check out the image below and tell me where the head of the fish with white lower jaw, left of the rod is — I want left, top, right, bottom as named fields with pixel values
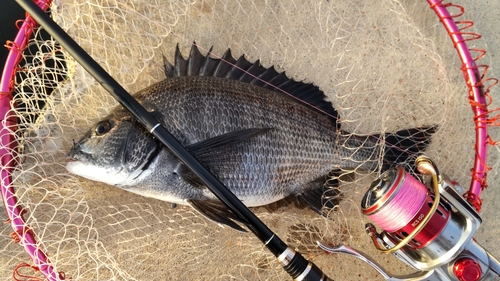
left=66, top=112, right=160, bottom=187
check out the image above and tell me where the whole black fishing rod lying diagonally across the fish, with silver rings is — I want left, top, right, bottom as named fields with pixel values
left=16, top=0, right=331, bottom=281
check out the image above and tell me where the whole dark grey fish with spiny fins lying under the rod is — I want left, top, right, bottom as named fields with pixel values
left=66, top=44, right=436, bottom=231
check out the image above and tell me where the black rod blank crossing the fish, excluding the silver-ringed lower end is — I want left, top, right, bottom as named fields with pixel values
left=16, top=0, right=278, bottom=247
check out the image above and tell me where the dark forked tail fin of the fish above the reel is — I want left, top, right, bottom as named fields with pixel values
left=379, top=126, right=437, bottom=172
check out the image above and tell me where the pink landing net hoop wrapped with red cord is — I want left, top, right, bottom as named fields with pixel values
left=0, top=0, right=498, bottom=280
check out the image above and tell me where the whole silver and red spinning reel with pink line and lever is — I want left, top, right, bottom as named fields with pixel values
left=318, top=156, right=500, bottom=281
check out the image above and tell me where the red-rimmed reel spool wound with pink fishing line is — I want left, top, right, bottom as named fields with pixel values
left=361, top=164, right=450, bottom=250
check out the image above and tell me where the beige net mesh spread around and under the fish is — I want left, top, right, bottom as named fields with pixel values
left=0, top=0, right=500, bottom=280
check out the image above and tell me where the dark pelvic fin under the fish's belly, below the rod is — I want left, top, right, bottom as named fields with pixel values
left=186, top=200, right=247, bottom=232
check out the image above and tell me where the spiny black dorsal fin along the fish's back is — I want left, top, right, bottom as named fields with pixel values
left=163, top=42, right=340, bottom=129
